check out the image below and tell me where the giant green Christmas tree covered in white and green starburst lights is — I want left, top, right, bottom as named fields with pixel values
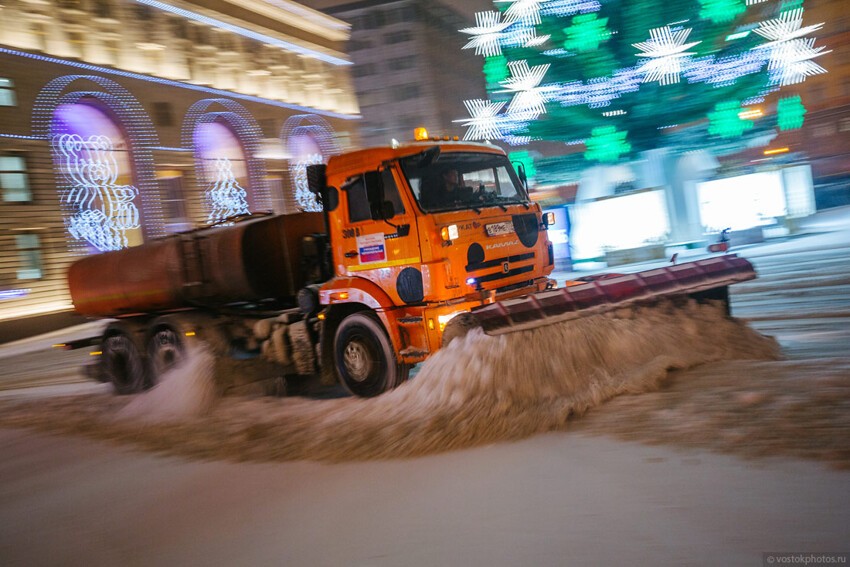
left=461, top=0, right=825, bottom=162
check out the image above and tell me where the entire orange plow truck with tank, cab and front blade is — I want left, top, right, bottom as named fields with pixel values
left=68, top=140, right=755, bottom=396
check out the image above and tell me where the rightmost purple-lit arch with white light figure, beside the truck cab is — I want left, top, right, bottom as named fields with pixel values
left=280, top=114, right=339, bottom=212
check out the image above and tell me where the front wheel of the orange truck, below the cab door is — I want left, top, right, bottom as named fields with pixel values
left=334, top=313, right=410, bottom=398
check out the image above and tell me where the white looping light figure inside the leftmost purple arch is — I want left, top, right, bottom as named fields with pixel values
left=52, top=134, right=139, bottom=252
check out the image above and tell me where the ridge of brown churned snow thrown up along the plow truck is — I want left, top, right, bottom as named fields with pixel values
left=0, top=302, right=779, bottom=461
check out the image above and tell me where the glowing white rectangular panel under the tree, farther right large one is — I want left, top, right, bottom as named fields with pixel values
left=697, top=171, right=787, bottom=232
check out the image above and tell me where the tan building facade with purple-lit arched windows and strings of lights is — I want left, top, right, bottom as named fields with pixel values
left=0, top=0, right=359, bottom=319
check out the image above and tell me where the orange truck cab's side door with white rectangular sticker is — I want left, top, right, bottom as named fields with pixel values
left=342, top=168, right=421, bottom=303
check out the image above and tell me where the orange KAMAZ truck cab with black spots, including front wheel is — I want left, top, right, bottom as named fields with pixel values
left=311, top=141, right=554, bottom=395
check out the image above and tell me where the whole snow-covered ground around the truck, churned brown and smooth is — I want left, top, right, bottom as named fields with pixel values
left=0, top=211, right=850, bottom=566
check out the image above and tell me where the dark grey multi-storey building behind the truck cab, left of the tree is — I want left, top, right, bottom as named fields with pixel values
left=324, top=0, right=487, bottom=145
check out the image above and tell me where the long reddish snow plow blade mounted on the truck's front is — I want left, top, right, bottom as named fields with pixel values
left=472, top=254, right=756, bottom=335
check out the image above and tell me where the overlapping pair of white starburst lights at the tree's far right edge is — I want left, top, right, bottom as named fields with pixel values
left=753, top=8, right=829, bottom=86
